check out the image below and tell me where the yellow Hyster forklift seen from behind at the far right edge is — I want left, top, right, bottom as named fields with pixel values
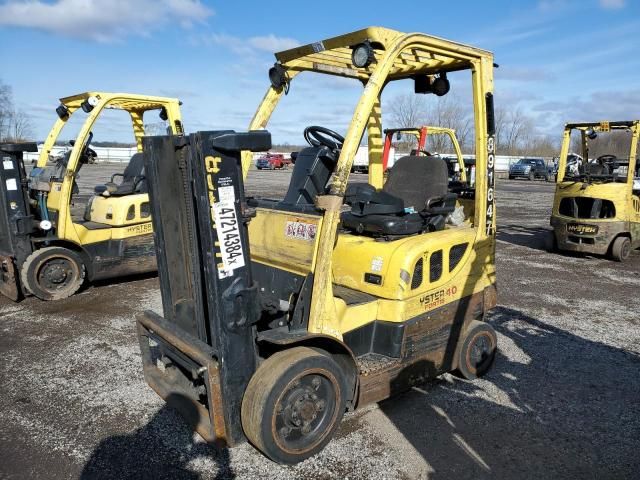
left=549, top=120, right=640, bottom=262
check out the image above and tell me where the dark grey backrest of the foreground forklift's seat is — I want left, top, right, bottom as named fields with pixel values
left=382, top=155, right=449, bottom=212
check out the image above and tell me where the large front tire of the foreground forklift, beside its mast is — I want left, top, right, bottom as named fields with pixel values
left=241, top=347, right=347, bottom=464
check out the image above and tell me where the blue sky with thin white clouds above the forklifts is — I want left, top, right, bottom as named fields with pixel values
left=0, top=0, right=640, bottom=144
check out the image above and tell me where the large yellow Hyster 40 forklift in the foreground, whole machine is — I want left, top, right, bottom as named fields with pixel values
left=137, top=27, right=497, bottom=463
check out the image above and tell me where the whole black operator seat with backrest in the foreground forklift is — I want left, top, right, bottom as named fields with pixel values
left=341, top=155, right=457, bottom=236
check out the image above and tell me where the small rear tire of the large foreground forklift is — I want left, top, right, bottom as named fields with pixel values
left=455, top=320, right=498, bottom=380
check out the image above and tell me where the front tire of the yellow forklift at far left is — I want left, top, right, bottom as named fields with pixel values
left=20, top=247, right=85, bottom=300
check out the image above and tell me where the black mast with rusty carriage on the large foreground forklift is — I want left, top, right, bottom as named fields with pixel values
left=138, top=131, right=271, bottom=445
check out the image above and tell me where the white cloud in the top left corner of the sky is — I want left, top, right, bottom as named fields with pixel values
left=0, top=0, right=214, bottom=42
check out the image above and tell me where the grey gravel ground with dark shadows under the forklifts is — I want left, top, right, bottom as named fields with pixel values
left=0, top=166, right=640, bottom=479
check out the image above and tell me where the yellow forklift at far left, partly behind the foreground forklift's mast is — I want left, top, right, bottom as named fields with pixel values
left=0, top=92, right=183, bottom=300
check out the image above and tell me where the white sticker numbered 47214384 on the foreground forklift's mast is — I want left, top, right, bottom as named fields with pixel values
left=211, top=186, right=245, bottom=278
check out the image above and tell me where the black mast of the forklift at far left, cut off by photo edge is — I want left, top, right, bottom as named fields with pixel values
left=0, top=143, right=38, bottom=300
